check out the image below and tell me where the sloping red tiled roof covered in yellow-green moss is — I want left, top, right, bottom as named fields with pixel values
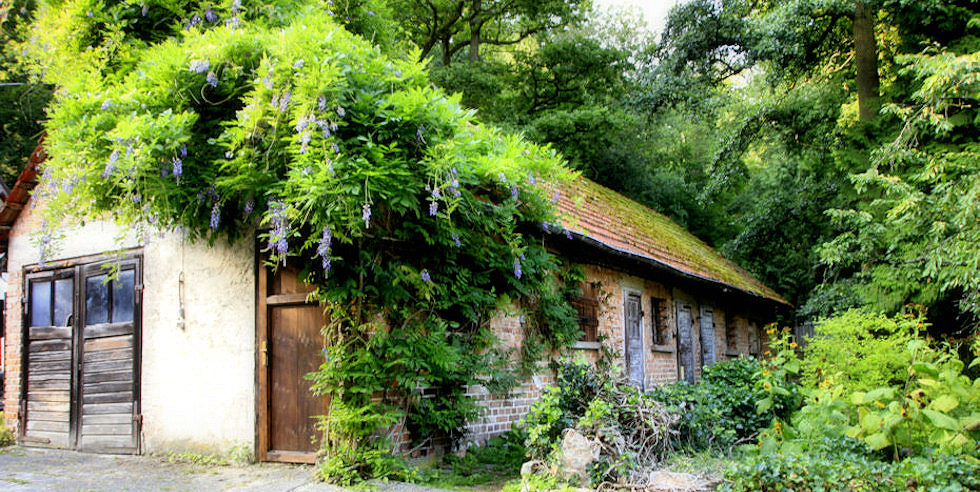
left=558, top=177, right=788, bottom=304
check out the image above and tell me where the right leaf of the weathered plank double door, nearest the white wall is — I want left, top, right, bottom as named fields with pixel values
left=76, top=262, right=140, bottom=454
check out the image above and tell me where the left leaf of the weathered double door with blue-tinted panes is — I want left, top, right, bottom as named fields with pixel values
left=21, top=270, right=75, bottom=448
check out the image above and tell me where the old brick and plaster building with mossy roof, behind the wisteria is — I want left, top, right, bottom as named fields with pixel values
left=0, top=148, right=786, bottom=462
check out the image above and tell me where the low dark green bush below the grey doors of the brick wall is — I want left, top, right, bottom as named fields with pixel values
left=649, top=358, right=793, bottom=449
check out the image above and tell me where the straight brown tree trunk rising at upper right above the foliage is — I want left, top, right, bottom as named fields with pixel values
left=854, top=0, right=879, bottom=121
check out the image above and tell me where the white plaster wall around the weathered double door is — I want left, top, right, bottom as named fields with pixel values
left=8, top=209, right=255, bottom=453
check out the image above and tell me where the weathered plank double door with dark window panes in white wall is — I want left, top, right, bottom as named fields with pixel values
left=20, top=257, right=142, bottom=454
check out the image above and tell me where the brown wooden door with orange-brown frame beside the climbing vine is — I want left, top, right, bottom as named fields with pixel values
left=258, top=267, right=328, bottom=463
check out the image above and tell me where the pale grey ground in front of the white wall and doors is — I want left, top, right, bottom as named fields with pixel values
left=0, top=446, right=452, bottom=492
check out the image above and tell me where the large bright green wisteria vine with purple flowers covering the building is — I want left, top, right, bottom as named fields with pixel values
left=24, top=0, right=578, bottom=481
